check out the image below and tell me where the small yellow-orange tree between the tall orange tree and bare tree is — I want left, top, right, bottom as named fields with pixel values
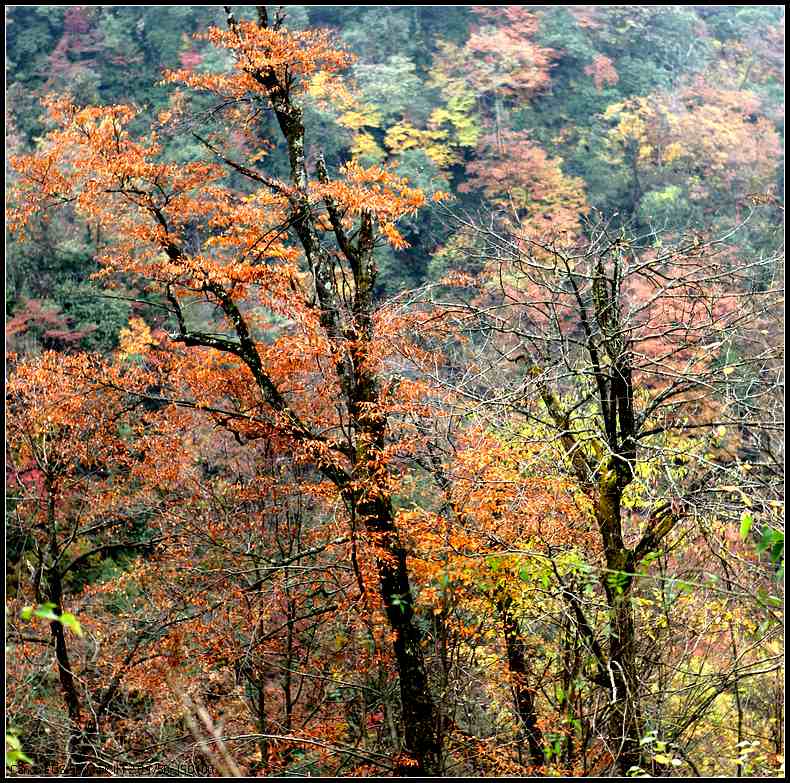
left=414, top=426, right=581, bottom=773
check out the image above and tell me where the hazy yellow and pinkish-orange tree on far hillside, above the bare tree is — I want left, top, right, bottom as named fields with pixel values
left=604, top=77, right=780, bottom=226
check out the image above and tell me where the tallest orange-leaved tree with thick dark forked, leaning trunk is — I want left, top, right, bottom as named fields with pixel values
left=13, top=7, right=440, bottom=774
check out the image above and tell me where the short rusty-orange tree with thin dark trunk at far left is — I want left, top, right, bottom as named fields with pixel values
left=6, top=351, right=170, bottom=775
